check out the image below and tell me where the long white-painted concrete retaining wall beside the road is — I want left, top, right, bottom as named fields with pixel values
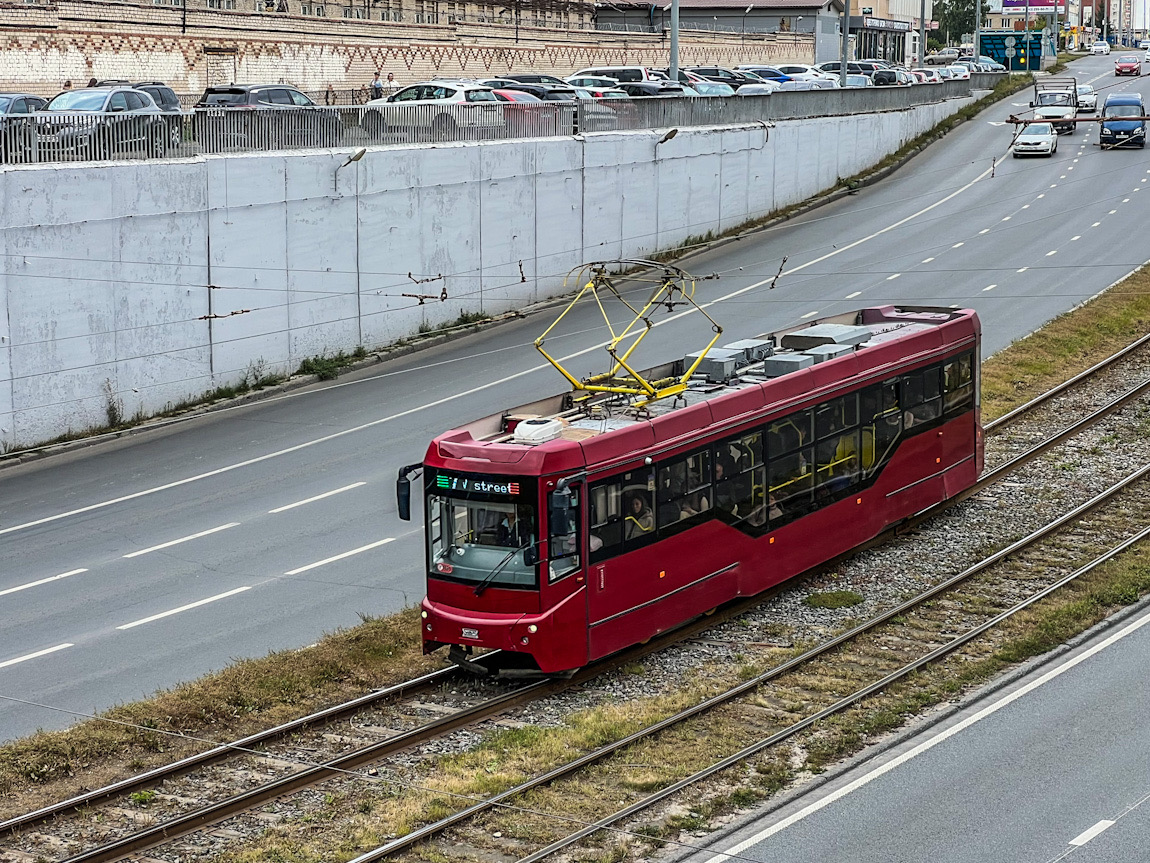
left=0, top=98, right=969, bottom=450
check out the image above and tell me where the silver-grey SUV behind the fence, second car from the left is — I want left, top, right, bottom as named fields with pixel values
left=36, top=86, right=170, bottom=159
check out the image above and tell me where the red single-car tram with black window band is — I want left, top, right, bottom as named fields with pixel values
left=399, top=306, right=983, bottom=673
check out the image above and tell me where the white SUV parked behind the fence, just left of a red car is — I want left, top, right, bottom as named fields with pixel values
left=360, top=81, right=506, bottom=140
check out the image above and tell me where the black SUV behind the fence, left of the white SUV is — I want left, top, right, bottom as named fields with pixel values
left=194, top=84, right=343, bottom=152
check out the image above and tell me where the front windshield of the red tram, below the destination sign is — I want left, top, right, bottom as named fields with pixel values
left=427, top=494, right=538, bottom=588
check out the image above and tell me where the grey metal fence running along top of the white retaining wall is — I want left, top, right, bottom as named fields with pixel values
left=0, top=75, right=1002, bottom=165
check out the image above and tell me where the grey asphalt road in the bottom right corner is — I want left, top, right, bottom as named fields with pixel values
left=675, top=608, right=1150, bottom=863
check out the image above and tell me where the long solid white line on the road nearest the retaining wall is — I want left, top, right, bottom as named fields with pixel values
left=0, top=154, right=1010, bottom=536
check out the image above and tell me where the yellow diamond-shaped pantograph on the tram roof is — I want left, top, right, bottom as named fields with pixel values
left=535, top=259, right=722, bottom=407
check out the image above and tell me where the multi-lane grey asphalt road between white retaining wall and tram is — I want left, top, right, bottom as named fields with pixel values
left=0, top=56, right=1150, bottom=739
